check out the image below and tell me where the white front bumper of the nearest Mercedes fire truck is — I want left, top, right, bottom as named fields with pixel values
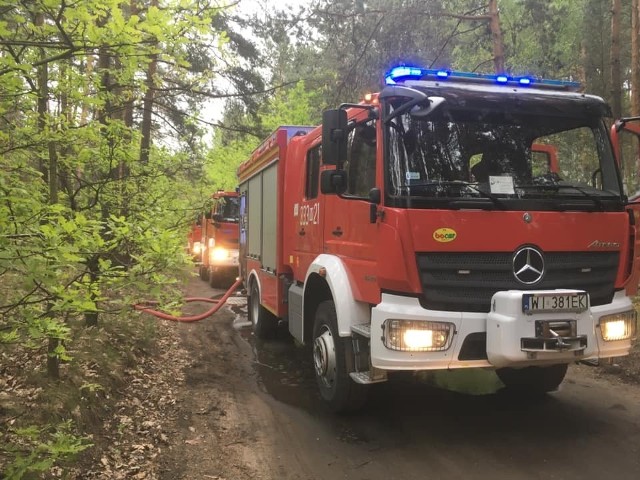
left=370, top=290, right=634, bottom=370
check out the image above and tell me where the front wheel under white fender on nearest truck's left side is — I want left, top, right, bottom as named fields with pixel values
left=313, top=300, right=368, bottom=412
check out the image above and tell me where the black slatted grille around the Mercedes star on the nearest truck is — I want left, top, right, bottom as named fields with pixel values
left=416, top=252, right=619, bottom=312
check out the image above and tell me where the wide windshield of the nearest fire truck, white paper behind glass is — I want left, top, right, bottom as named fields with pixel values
left=385, top=106, right=620, bottom=210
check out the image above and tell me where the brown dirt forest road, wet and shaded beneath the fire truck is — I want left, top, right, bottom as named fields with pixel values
left=159, top=279, right=640, bottom=480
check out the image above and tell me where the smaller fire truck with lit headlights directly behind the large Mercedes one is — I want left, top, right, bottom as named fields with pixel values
left=198, top=191, right=239, bottom=288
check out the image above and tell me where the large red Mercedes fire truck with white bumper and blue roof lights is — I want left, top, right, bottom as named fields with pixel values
left=238, top=66, right=640, bottom=411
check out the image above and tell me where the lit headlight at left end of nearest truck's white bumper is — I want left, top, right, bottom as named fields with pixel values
left=383, top=319, right=455, bottom=352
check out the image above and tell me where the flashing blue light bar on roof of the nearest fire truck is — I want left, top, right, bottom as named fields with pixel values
left=384, top=65, right=580, bottom=90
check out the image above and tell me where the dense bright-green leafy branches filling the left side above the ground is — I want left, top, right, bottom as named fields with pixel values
left=0, top=0, right=226, bottom=346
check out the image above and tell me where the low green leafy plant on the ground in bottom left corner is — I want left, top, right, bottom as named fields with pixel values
left=0, top=421, right=92, bottom=480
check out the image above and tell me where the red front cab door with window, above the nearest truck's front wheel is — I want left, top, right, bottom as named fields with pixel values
left=324, top=120, right=381, bottom=301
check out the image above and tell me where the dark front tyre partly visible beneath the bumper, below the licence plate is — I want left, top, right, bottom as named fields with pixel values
left=496, top=363, right=569, bottom=395
